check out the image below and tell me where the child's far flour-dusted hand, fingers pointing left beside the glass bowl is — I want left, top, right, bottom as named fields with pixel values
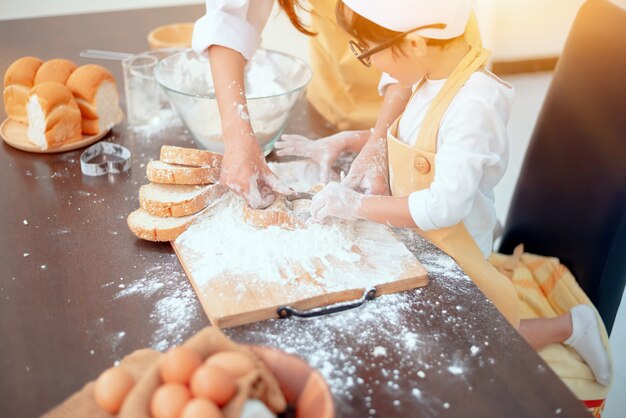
left=275, top=131, right=357, bottom=183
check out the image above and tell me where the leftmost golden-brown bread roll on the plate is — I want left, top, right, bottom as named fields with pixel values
left=3, top=57, right=43, bottom=125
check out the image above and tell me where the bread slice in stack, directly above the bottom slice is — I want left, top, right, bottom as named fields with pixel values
left=139, top=183, right=227, bottom=217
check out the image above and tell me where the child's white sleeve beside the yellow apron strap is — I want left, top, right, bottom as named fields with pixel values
left=409, top=99, right=508, bottom=231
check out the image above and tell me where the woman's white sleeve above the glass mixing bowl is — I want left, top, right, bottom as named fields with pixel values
left=191, top=0, right=274, bottom=59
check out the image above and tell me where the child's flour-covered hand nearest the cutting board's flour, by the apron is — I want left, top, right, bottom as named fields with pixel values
left=311, top=182, right=364, bottom=222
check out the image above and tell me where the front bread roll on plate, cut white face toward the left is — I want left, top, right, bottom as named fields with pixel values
left=26, top=83, right=82, bottom=150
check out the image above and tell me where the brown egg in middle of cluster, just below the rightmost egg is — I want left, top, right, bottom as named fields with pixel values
left=191, top=366, right=237, bottom=407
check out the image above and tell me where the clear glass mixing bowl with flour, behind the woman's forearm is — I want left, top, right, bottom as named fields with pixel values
left=154, top=49, right=312, bottom=155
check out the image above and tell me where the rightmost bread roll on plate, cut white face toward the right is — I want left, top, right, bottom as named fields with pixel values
left=67, top=64, right=124, bottom=135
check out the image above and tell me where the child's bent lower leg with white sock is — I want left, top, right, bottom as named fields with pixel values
left=519, top=305, right=611, bottom=385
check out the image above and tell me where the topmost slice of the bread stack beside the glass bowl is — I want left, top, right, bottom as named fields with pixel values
left=146, top=161, right=220, bottom=184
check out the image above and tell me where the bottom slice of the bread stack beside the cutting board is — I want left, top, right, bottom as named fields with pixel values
left=126, top=209, right=202, bottom=242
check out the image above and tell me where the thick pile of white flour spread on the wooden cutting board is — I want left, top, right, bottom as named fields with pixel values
left=176, top=193, right=360, bottom=283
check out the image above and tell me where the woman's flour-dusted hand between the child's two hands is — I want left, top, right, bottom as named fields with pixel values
left=341, top=138, right=391, bottom=196
